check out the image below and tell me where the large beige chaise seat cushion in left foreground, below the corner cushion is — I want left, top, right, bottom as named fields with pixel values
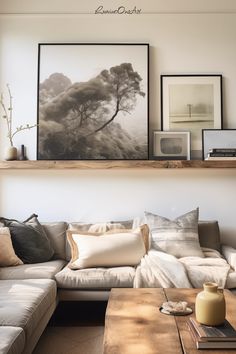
left=0, top=279, right=57, bottom=340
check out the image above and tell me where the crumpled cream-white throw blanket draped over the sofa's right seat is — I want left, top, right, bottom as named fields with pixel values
left=134, top=248, right=231, bottom=288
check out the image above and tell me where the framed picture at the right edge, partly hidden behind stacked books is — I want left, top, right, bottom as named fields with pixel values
left=202, top=129, right=236, bottom=160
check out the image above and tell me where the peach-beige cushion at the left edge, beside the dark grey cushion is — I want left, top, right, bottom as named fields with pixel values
left=0, top=227, right=23, bottom=267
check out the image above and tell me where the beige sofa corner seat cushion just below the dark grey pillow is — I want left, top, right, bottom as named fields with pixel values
left=0, top=260, right=66, bottom=280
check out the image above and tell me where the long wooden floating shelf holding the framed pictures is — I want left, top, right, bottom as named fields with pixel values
left=0, top=160, right=236, bottom=170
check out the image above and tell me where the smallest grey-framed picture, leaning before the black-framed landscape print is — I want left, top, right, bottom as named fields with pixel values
left=153, top=131, right=190, bottom=160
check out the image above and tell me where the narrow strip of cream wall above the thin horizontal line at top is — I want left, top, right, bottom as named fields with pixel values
left=0, top=0, right=236, bottom=14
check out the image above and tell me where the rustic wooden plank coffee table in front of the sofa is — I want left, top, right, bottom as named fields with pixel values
left=103, top=288, right=236, bottom=354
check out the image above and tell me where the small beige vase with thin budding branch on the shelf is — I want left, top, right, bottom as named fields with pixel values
left=0, top=84, right=37, bottom=160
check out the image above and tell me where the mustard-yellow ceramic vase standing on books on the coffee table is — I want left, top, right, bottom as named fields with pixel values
left=195, top=282, right=226, bottom=326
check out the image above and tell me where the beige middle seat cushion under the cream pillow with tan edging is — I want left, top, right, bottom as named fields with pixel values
left=55, top=267, right=135, bottom=289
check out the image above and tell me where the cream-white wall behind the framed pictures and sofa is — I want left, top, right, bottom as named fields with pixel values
left=0, top=0, right=236, bottom=246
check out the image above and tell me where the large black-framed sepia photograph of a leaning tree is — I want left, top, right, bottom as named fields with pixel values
left=37, top=43, right=149, bottom=160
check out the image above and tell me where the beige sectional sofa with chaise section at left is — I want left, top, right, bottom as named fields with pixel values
left=0, top=216, right=236, bottom=354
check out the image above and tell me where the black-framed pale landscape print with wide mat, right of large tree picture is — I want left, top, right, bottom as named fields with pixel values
left=161, top=75, right=222, bottom=159
